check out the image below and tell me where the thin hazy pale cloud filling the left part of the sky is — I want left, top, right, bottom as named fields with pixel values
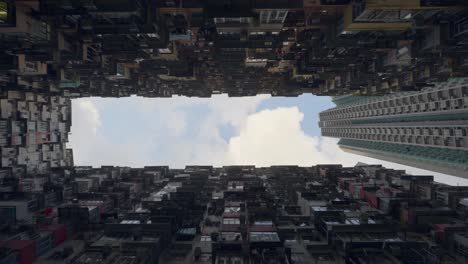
left=69, top=95, right=267, bottom=168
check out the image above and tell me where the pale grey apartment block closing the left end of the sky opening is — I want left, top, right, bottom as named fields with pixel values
left=0, top=91, right=73, bottom=175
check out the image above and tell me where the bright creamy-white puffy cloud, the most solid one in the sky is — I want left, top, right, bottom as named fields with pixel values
left=228, top=107, right=316, bottom=166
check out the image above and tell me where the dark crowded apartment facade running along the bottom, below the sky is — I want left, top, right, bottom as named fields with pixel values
left=0, top=163, right=468, bottom=264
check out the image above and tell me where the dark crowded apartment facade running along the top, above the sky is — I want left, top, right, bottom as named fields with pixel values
left=0, top=0, right=468, bottom=98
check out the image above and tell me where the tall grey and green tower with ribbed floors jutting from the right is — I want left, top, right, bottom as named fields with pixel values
left=319, top=78, right=468, bottom=177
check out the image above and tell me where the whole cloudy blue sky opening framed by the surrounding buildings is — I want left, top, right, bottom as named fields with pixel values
left=68, top=95, right=468, bottom=185
